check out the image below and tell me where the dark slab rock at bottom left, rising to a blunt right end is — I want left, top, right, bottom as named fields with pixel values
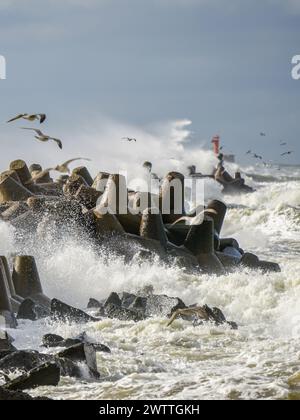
left=4, top=363, right=60, bottom=391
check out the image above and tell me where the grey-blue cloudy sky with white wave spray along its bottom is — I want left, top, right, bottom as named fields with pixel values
left=0, top=0, right=300, bottom=175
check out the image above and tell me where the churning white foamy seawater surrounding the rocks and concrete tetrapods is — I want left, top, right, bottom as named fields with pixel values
left=0, top=164, right=300, bottom=399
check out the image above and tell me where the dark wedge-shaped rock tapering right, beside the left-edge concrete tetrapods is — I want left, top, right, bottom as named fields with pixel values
left=51, top=299, right=99, bottom=323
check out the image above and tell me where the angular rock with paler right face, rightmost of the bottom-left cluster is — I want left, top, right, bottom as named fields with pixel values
left=57, top=343, right=100, bottom=379
